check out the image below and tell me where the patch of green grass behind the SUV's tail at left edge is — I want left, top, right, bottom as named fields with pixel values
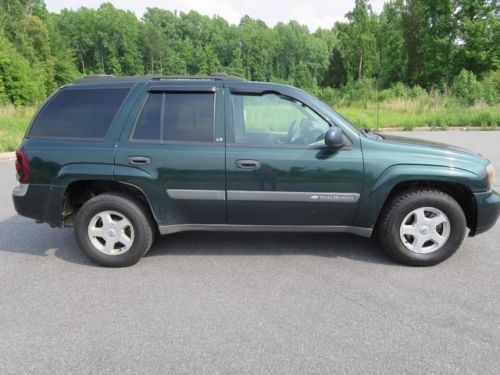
left=0, top=106, right=35, bottom=152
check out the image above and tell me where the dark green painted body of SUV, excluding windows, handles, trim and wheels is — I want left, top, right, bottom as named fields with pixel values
left=14, top=80, right=500, bottom=239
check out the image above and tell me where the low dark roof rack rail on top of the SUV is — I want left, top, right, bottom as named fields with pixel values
left=74, top=73, right=246, bottom=83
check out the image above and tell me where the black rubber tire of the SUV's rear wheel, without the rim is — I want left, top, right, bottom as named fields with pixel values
left=74, top=193, right=155, bottom=267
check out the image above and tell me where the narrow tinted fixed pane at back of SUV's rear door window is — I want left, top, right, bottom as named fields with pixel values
left=132, top=94, right=162, bottom=141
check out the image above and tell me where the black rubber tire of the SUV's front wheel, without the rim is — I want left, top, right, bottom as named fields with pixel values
left=376, top=188, right=466, bottom=266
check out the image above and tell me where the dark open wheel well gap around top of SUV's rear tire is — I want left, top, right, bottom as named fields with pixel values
left=61, top=180, right=158, bottom=226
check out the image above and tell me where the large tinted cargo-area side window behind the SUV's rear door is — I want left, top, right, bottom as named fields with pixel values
left=30, top=89, right=129, bottom=139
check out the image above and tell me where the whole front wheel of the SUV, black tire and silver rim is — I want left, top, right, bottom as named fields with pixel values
left=377, top=189, right=466, bottom=266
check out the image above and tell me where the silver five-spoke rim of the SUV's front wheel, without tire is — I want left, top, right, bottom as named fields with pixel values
left=399, top=207, right=450, bottom=254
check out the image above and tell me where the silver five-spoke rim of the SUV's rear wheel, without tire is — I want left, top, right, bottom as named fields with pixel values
left=88, top=211, right=135, bottom=255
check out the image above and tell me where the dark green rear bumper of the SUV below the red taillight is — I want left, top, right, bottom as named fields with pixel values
left=12, top=184, right=64, bottom=226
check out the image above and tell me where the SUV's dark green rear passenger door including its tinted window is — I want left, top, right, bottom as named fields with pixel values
left=114, top=81, right=226, bottom=229
